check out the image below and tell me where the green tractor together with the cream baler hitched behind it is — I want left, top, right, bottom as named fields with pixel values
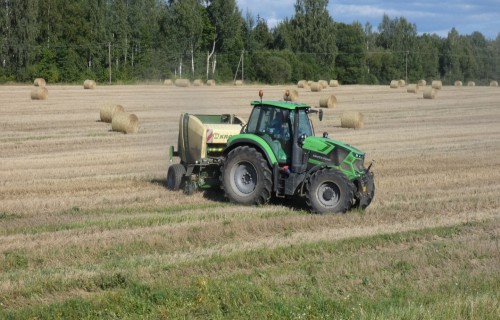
left=167, top=93, right=375, bottom=213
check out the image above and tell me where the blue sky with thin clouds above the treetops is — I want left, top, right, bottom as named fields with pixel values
left=236, top=0, right=500, bottom=40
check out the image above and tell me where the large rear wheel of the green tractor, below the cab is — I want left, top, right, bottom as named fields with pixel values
left=222, top=146, right=273, bottom=205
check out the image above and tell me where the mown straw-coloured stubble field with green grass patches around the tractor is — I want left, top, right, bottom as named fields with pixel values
left=0, top=85, right=500, bottom=319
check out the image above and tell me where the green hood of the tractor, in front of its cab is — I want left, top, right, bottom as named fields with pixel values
left=302, top=137, right=365, bottom=171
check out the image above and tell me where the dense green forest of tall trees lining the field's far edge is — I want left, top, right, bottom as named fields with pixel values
left=0, top=0, right=500, bottom=85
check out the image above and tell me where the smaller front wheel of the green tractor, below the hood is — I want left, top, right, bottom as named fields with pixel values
left=306, top=169, right=354, bottom=213
